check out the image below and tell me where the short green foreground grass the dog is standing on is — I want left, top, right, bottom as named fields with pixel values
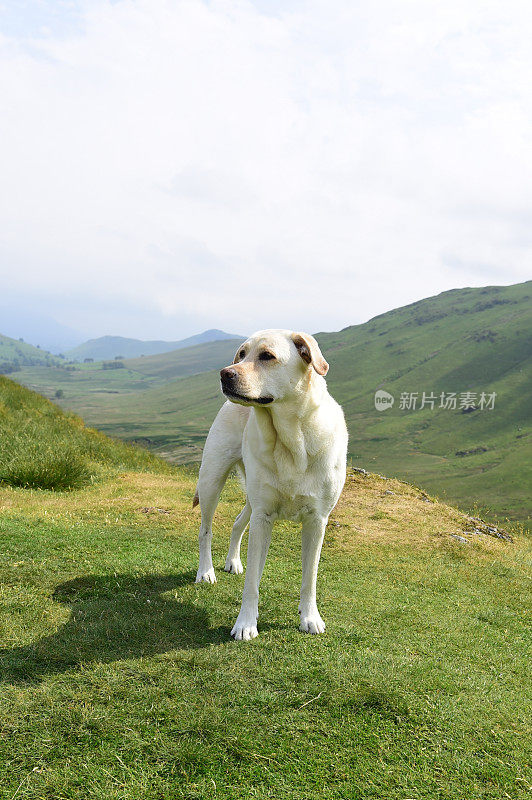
left=0, top=470, right=532, bottom=800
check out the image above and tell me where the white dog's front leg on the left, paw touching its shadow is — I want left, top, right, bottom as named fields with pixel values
left=231, top=513, right=273, bottom=640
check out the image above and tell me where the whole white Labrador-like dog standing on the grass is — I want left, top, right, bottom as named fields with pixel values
left=193, top=330, right=347, bottom=640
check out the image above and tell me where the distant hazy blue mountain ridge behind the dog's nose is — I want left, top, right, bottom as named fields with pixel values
left=65, top=328, right=246, bottom=361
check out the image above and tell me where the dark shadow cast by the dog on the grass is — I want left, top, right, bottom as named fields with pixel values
left=0, top=572, right=229, bottom=682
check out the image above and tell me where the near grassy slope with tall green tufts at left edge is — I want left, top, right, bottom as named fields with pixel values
left=0, top=376, right=167, bottom=490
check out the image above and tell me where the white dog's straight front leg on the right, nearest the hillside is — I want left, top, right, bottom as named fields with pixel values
left=299, top=516, right=327, bottom=633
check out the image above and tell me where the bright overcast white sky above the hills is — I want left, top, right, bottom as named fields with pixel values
left=0, top=0, right=532, bottom=338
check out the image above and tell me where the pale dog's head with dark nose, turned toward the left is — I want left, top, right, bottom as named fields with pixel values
left=220, top=330, right=329, bottom=406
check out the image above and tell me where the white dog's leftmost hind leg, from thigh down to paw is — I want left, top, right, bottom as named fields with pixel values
left=193, top=403, right=249, bottom=583
